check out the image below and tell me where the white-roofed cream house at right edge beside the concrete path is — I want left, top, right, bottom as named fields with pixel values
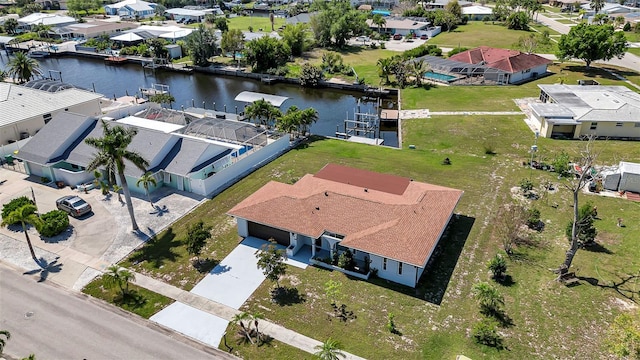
left=530, top=84, right=640, bottom=139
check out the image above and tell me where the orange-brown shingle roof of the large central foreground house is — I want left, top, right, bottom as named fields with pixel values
left=228, top=165, right=463, bottom=267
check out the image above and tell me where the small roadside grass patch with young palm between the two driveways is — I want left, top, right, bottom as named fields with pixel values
left=82, top=277, right=173, bottom=319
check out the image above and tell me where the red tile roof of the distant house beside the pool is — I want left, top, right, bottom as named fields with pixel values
left=449, top=46, right=552, bottom=73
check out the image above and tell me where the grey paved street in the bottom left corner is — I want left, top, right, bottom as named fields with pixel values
left=0, top=266, right=236, bottom=360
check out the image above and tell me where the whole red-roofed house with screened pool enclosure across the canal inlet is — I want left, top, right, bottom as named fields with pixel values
left=449, top=46, right=552, bottom=84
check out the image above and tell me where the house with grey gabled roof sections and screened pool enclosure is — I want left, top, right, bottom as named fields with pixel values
left=15, top=105, right=289, bottom=196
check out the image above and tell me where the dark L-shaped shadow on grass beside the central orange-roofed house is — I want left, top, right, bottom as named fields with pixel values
left=360, top=215, right=476, bottom=305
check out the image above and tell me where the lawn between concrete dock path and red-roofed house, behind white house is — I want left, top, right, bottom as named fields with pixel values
left=402, top=63, right=640, bottom=111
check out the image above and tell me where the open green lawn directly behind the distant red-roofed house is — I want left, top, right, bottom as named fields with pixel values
left=428, top=21, right=544, bottom=49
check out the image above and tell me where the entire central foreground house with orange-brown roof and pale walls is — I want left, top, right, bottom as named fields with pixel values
left=228, top=164, right=463, bottom=287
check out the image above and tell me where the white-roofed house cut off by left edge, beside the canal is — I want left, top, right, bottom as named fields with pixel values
left=0, top=79, right=103, bottom=146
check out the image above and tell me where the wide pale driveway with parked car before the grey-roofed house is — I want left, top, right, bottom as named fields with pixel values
left=0, top=168, right=203, bottom=290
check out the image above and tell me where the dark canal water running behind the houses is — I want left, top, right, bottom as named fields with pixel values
left=0, top=54, right=398, bottom=147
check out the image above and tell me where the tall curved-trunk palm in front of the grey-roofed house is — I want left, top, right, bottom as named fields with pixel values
left=85, top=120, right=149, bottom=231
